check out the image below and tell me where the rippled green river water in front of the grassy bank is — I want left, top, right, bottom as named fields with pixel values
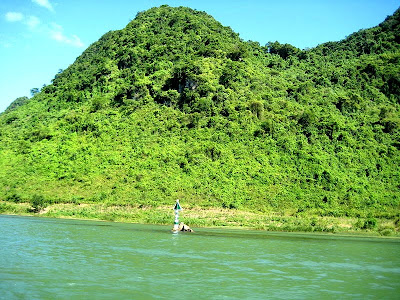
left=0, top=215, right=400, bottom=299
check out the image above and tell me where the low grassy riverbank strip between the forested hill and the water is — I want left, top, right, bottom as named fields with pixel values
left=0, top=201, right=400, bottom=237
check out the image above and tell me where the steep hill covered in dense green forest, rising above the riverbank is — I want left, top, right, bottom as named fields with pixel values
left=0, top=6, right=400, bottom=218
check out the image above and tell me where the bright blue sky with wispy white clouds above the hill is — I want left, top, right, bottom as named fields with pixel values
left=0, top=0, right=399, bottom=112
